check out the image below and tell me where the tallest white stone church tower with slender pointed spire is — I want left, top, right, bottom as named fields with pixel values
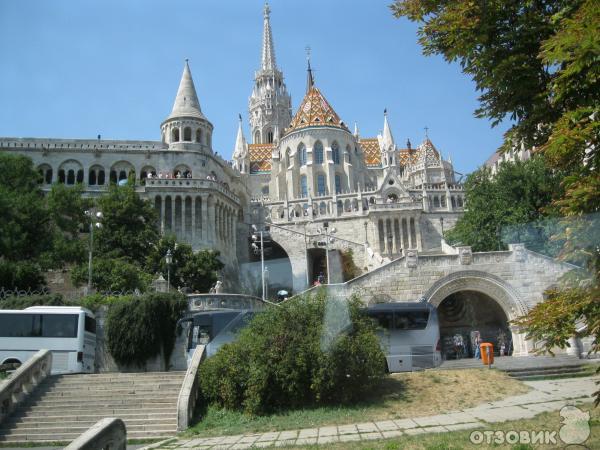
left=248, top=3, right=292, bottom=144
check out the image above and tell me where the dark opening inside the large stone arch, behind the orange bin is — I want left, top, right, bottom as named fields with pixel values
left=437, top=290, right=513, bottom=359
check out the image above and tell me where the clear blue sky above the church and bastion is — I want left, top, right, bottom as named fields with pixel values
left=0, top=0, right=507, bottom=173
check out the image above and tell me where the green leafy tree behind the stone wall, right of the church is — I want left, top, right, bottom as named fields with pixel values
left=445, top=156, right=561, bottom=256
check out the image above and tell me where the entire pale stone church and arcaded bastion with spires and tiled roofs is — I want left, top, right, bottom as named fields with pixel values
left=0, top=5, right=464, bottom=291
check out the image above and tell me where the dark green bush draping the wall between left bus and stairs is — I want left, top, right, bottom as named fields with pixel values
left=106, top=293, right=187, bottom=366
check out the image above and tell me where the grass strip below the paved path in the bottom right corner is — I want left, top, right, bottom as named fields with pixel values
left=286, top=403, right=600, bottom=450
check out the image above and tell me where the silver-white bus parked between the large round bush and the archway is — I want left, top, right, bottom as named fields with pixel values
left=365, top=302, right=442, bottom=372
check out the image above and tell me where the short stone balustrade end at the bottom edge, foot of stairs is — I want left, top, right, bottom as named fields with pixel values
left=65, top=417, right=127, bottom=450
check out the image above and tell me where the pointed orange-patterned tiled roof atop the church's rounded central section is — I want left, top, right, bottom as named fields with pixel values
left=285, top=86, right=348, bottom=133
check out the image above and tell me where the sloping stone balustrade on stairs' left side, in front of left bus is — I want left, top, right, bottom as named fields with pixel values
left=0, top=350, right=52, bottom=423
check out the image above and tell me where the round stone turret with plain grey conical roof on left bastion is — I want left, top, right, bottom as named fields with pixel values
left=160, top=59, right=213, bottom=150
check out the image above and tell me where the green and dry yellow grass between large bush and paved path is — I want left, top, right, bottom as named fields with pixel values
left=183, top=369, right=529, bottom=436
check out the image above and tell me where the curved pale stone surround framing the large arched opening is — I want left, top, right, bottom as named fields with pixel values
left=424, top=270, right=528, bottom=356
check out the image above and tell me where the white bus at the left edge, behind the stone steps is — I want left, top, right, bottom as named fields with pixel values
left=0, top=306, right=96, bottom=374
